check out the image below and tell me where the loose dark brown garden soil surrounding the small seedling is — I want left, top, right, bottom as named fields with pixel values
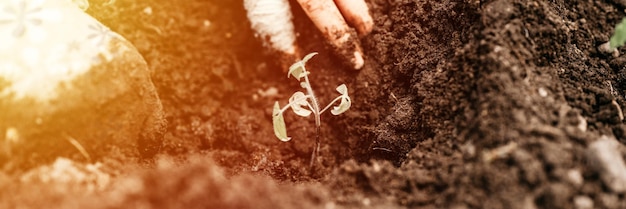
left=0, top=0, right=626, bottom=209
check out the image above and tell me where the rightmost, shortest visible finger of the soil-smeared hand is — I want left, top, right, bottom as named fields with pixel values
left=335, top=0, right=374, bottom=36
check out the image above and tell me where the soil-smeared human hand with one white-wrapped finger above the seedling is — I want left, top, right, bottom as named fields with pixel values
left=244, top=0, right=374, bottom=69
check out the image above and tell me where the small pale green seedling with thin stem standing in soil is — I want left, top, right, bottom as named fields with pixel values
left=272, top=52, right=351, bottom=169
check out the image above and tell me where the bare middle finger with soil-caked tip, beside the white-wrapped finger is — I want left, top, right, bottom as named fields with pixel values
left=298, top=0, right=364, bottom=69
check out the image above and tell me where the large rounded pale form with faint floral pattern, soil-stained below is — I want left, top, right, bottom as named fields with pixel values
left=0, top=0, right=165, bottom=169
